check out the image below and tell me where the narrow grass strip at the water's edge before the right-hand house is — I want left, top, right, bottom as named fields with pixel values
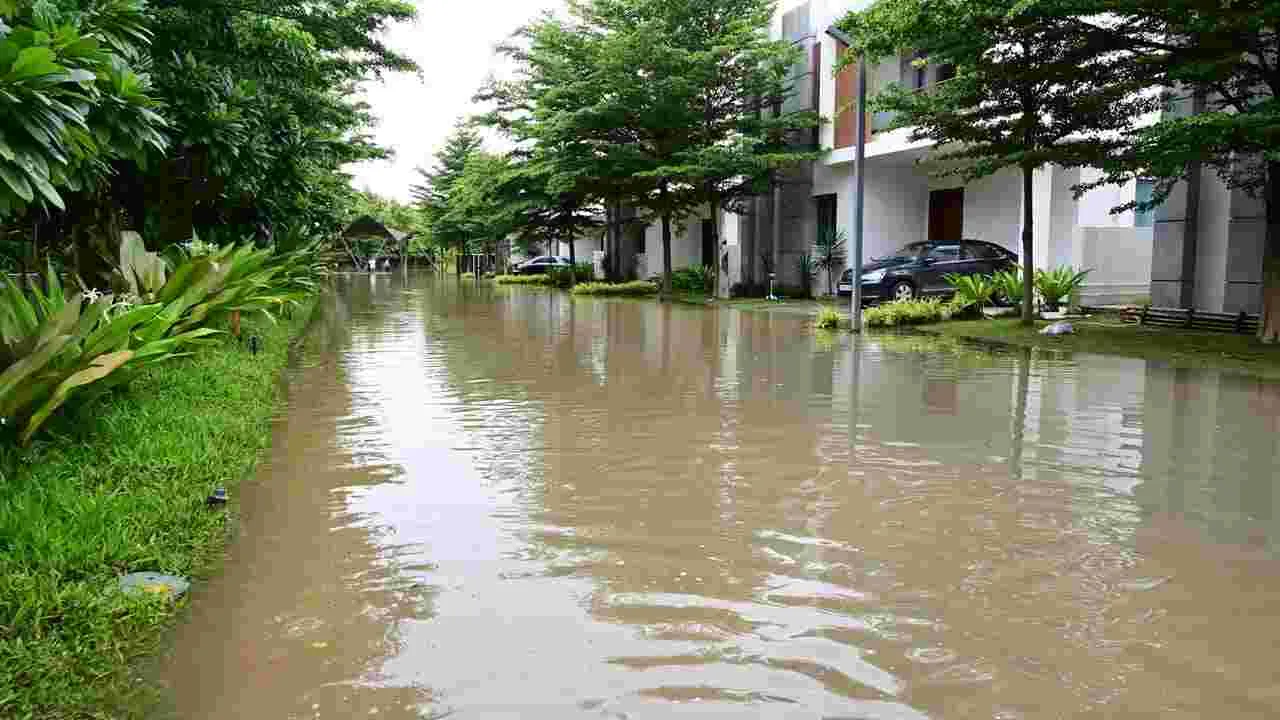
left=919, top=316, right=1280, bottom=377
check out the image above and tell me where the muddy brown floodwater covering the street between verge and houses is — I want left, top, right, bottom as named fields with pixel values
left=160, top=275, right=1280, bottom=720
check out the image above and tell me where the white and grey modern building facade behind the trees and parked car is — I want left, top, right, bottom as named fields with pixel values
left=627, top=0, right=1265, bottom=313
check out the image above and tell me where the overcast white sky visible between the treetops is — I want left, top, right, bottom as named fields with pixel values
left=351, top=0, right=562, bottom=200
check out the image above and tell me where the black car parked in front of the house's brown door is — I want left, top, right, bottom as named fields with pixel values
left=837, top=240, right=1018, bottom=302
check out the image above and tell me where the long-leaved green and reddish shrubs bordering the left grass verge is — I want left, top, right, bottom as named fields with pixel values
left=0, top=240, right=328, bottom=445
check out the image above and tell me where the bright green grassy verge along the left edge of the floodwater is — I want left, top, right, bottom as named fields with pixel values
left=0, top=299, right=308, bottom=717
